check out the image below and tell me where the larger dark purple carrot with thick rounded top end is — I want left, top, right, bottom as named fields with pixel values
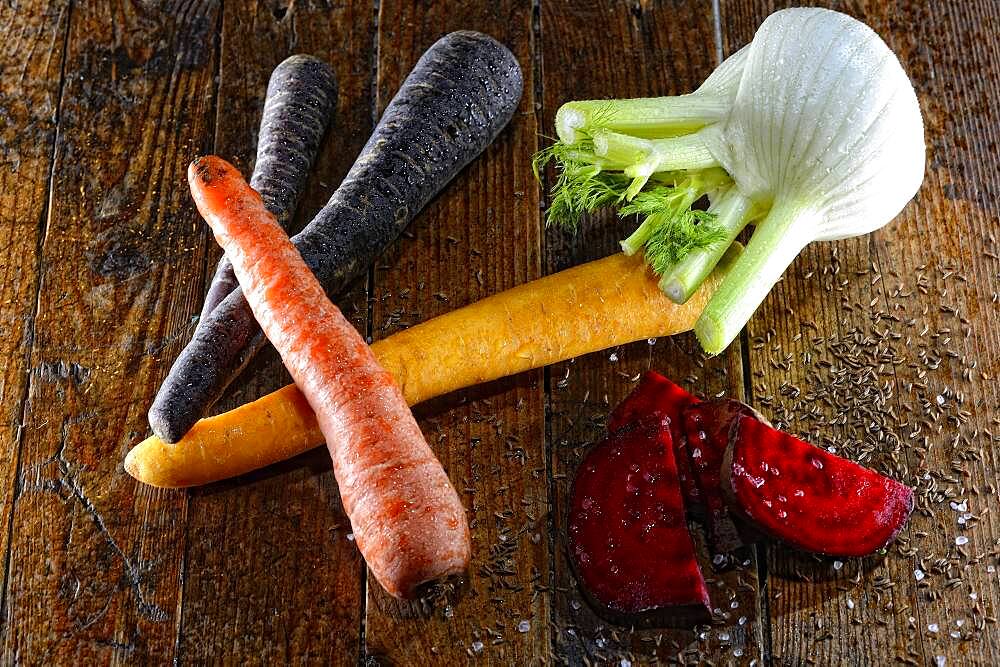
left=149, top=31, right=523, bottom=442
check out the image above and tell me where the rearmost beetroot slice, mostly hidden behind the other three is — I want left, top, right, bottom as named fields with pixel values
left=608, top=371, right=705, bottom=518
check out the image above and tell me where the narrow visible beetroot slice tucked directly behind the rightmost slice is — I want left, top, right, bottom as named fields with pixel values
left=683, top=400, right=759, bottom=554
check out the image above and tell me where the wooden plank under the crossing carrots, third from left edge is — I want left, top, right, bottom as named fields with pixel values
left=179, top=2, right=374, bottom=664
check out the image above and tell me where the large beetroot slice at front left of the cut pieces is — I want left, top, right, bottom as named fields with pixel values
left=568, top=418, right=710, bottom=624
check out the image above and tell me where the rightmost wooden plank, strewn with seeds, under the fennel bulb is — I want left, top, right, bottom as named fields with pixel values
left=722, top=1, right=1000, bottom=665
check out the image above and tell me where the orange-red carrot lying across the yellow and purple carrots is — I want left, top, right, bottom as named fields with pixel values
left=188, top=156, right=471, bottom=597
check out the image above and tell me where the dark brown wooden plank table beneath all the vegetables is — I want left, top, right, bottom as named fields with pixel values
left=0, top=0, right=1000, bottom=665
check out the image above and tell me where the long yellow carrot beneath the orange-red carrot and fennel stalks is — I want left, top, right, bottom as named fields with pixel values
left=125, top=244, right=739, bottom=487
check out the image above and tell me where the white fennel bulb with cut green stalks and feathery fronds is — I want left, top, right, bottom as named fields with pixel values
left=538, top=8, right=925, bottom=354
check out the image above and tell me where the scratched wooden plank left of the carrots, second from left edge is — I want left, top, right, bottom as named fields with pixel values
left=3, top=2, right=218, bottom=664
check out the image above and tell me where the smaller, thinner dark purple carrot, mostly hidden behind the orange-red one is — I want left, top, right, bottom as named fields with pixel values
left=199, top=55, right=337, bottom=320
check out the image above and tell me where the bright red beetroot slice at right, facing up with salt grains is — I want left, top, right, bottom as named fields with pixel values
left=723, top=416, right=913, bottom=557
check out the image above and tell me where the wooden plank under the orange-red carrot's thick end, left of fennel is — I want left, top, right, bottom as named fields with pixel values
left=365, top=0, right=549, bottom=664
